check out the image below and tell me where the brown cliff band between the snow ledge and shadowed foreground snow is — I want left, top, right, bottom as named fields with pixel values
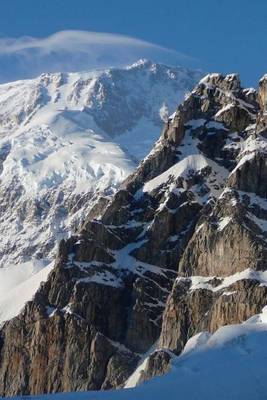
left=159, top=278, right=267, bottom=354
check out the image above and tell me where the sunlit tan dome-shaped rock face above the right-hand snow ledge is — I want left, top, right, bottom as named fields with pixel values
left=179, top=200, right=267, bottom=276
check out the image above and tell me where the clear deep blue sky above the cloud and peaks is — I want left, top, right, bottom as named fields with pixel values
left=0, top=0, right=267, bottom=85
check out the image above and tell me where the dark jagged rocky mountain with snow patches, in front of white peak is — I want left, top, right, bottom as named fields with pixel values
left=0, top=74, right=267, bottom=395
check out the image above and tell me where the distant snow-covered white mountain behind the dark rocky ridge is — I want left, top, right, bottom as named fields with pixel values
left=0, top=60, right=201, bottom=276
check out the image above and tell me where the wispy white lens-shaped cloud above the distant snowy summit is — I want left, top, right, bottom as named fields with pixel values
left=0, top=31, right=192, bottom=82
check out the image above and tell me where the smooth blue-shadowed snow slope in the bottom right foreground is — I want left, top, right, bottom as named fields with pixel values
left=6, top=307, right=267, bottom=400
